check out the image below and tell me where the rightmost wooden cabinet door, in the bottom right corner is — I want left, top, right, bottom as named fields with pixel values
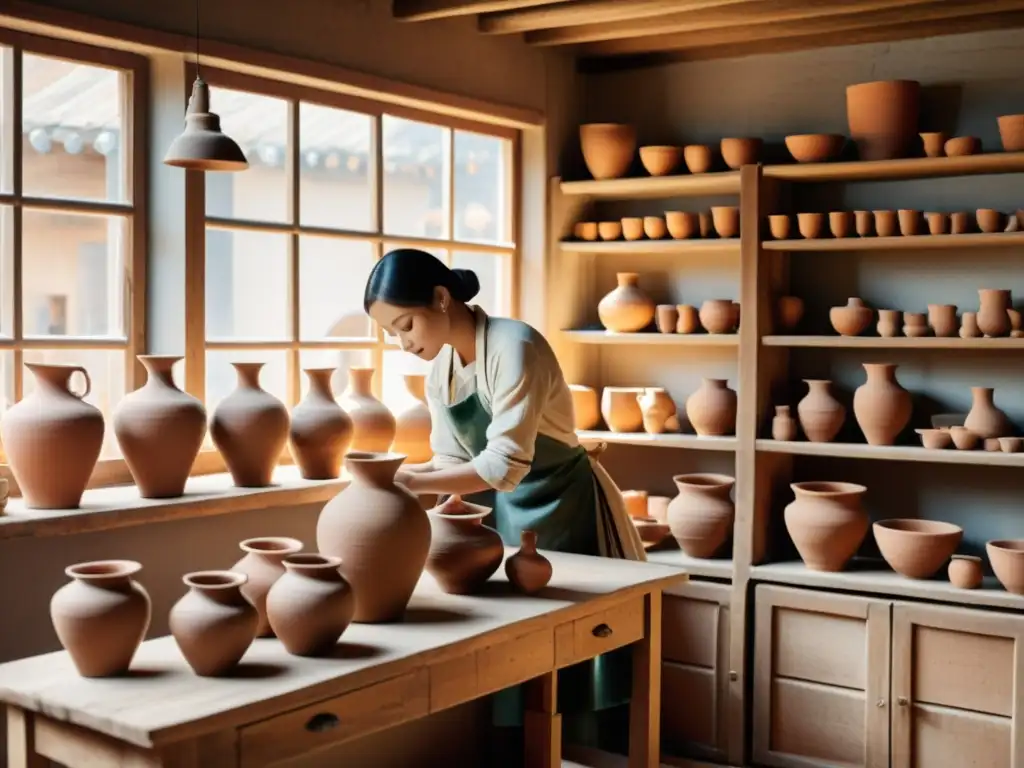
left=892, top=603, right=1024, bottom=768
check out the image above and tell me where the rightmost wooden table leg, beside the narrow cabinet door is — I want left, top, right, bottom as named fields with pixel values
left=629, top=591, right=662, bottom=768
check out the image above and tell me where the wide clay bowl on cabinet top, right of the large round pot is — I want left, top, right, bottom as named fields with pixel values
left=871, top=518, right=964, bottom=579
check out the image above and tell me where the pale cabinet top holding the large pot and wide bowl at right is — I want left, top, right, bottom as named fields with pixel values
left=751, top=560, right=1024, bottom=610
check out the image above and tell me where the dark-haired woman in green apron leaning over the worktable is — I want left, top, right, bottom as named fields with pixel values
left=364, top=249, right=645, bottom=757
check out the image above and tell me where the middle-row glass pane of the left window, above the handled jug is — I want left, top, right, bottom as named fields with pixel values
left=22, top=208, right=128, bottom=337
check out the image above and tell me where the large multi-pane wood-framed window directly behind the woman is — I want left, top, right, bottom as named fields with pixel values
left=187, top=68, right=516, bottom=446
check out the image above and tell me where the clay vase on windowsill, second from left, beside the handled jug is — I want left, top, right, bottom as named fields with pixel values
left=114, top=354, right=206, bottom=499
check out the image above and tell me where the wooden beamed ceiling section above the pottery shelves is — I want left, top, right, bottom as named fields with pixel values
left=392, top=0, right=1024, bottom=70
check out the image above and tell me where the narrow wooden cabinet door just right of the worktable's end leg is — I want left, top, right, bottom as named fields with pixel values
left=662, top=582, right=732, bottom=762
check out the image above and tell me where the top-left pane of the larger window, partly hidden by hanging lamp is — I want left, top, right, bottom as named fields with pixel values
left=206, top=87, right=289, bottom=221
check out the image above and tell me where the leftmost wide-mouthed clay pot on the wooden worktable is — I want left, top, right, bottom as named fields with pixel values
left=50, top=560, right=151, bottom=677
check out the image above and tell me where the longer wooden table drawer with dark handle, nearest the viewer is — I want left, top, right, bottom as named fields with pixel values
left=239, top=670, right=430, bottom=768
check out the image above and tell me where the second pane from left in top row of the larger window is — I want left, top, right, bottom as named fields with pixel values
left=299, top=101, right=376, bottom=231
